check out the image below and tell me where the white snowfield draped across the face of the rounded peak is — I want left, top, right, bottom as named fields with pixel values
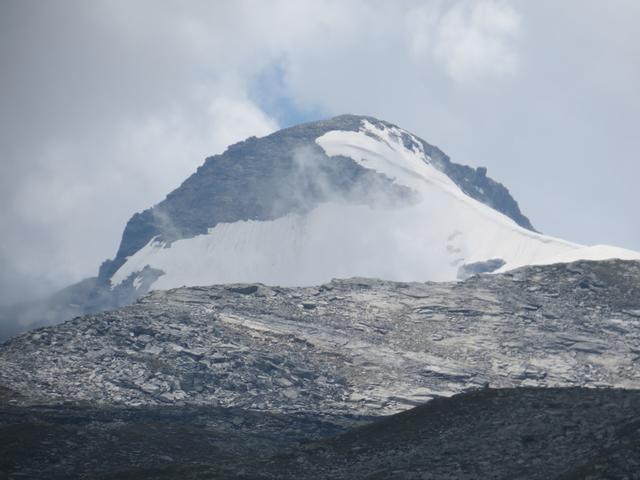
left=111, top=119, right=640, bottom=289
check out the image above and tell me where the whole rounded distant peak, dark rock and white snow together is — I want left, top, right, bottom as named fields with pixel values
left=102, top=115, right=640, bottom=294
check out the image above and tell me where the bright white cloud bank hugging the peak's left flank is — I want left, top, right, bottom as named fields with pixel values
left=1, top=88, right=277, bottom=294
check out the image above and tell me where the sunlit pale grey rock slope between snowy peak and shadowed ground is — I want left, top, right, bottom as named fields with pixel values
left=0, top=261, right=640, bottom=415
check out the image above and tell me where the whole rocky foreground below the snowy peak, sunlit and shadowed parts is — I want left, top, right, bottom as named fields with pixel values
left=0, top=260, right=640, bottom=479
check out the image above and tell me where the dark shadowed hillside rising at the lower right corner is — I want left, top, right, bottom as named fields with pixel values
left=242, top=388, right=640, bottom=480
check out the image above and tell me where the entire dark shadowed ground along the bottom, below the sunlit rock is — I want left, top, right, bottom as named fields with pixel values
left=0, top=388, right=640, bottom=480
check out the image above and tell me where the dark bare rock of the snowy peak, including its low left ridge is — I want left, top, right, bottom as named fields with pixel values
left=5, top=115, right=533, bottom=333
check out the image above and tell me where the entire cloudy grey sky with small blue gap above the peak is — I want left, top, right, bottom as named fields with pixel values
left=0, top=0, right=640, bottom=303
